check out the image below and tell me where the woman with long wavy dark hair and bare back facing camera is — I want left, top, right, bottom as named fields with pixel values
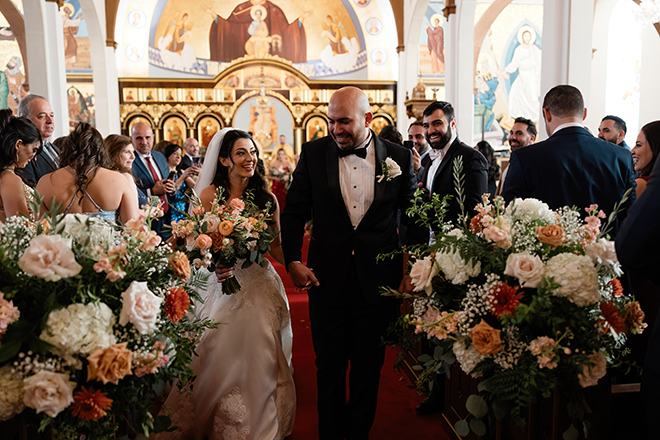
left=37, top=122, right=140, bottom=223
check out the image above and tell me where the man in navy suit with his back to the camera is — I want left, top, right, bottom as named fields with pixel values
left=503, top=85, right=636, bottom=236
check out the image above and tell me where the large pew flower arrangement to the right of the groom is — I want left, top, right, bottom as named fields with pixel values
left=383, top=162, right=646, bottom=440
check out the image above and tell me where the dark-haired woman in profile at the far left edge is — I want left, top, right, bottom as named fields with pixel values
left=0, top=109, right=41, bottom=221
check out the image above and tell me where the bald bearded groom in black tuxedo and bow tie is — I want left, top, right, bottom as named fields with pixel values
left=281, top=87, right=423, bottom=440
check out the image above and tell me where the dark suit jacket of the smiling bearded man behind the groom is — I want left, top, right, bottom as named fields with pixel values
left=418, top=138, right=488, bottom=222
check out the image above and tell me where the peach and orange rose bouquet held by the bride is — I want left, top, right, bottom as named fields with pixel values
left=171, top=188, right=276, bottom=295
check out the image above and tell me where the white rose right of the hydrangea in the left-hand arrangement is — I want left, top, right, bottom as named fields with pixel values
left=119, top=281, right=163, bottom=334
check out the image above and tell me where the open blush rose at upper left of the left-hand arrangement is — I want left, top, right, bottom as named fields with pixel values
left=18, top=235, right=82, bottom=281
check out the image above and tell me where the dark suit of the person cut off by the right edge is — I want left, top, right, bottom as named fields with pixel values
left=615, top=157, right=660, bottom=440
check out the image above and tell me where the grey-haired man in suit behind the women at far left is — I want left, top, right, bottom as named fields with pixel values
left=18, top=95, right=60, bottom=187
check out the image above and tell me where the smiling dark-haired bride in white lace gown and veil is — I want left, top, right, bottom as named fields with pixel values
left=157, top=128, right=296, bottom=440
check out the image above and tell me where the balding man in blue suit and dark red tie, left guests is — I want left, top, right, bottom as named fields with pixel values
left=131, top=122, right=174, bottom=235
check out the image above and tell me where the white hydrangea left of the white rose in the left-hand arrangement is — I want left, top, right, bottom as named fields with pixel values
left=40, top=303, right=117, bottom=355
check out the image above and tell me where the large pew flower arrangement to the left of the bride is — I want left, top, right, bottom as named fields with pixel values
left=0, top=195, right=215, bottom=440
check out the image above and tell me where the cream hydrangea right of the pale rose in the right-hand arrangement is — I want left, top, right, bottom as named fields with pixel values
left=545, top=253, right=600, bottom=307
